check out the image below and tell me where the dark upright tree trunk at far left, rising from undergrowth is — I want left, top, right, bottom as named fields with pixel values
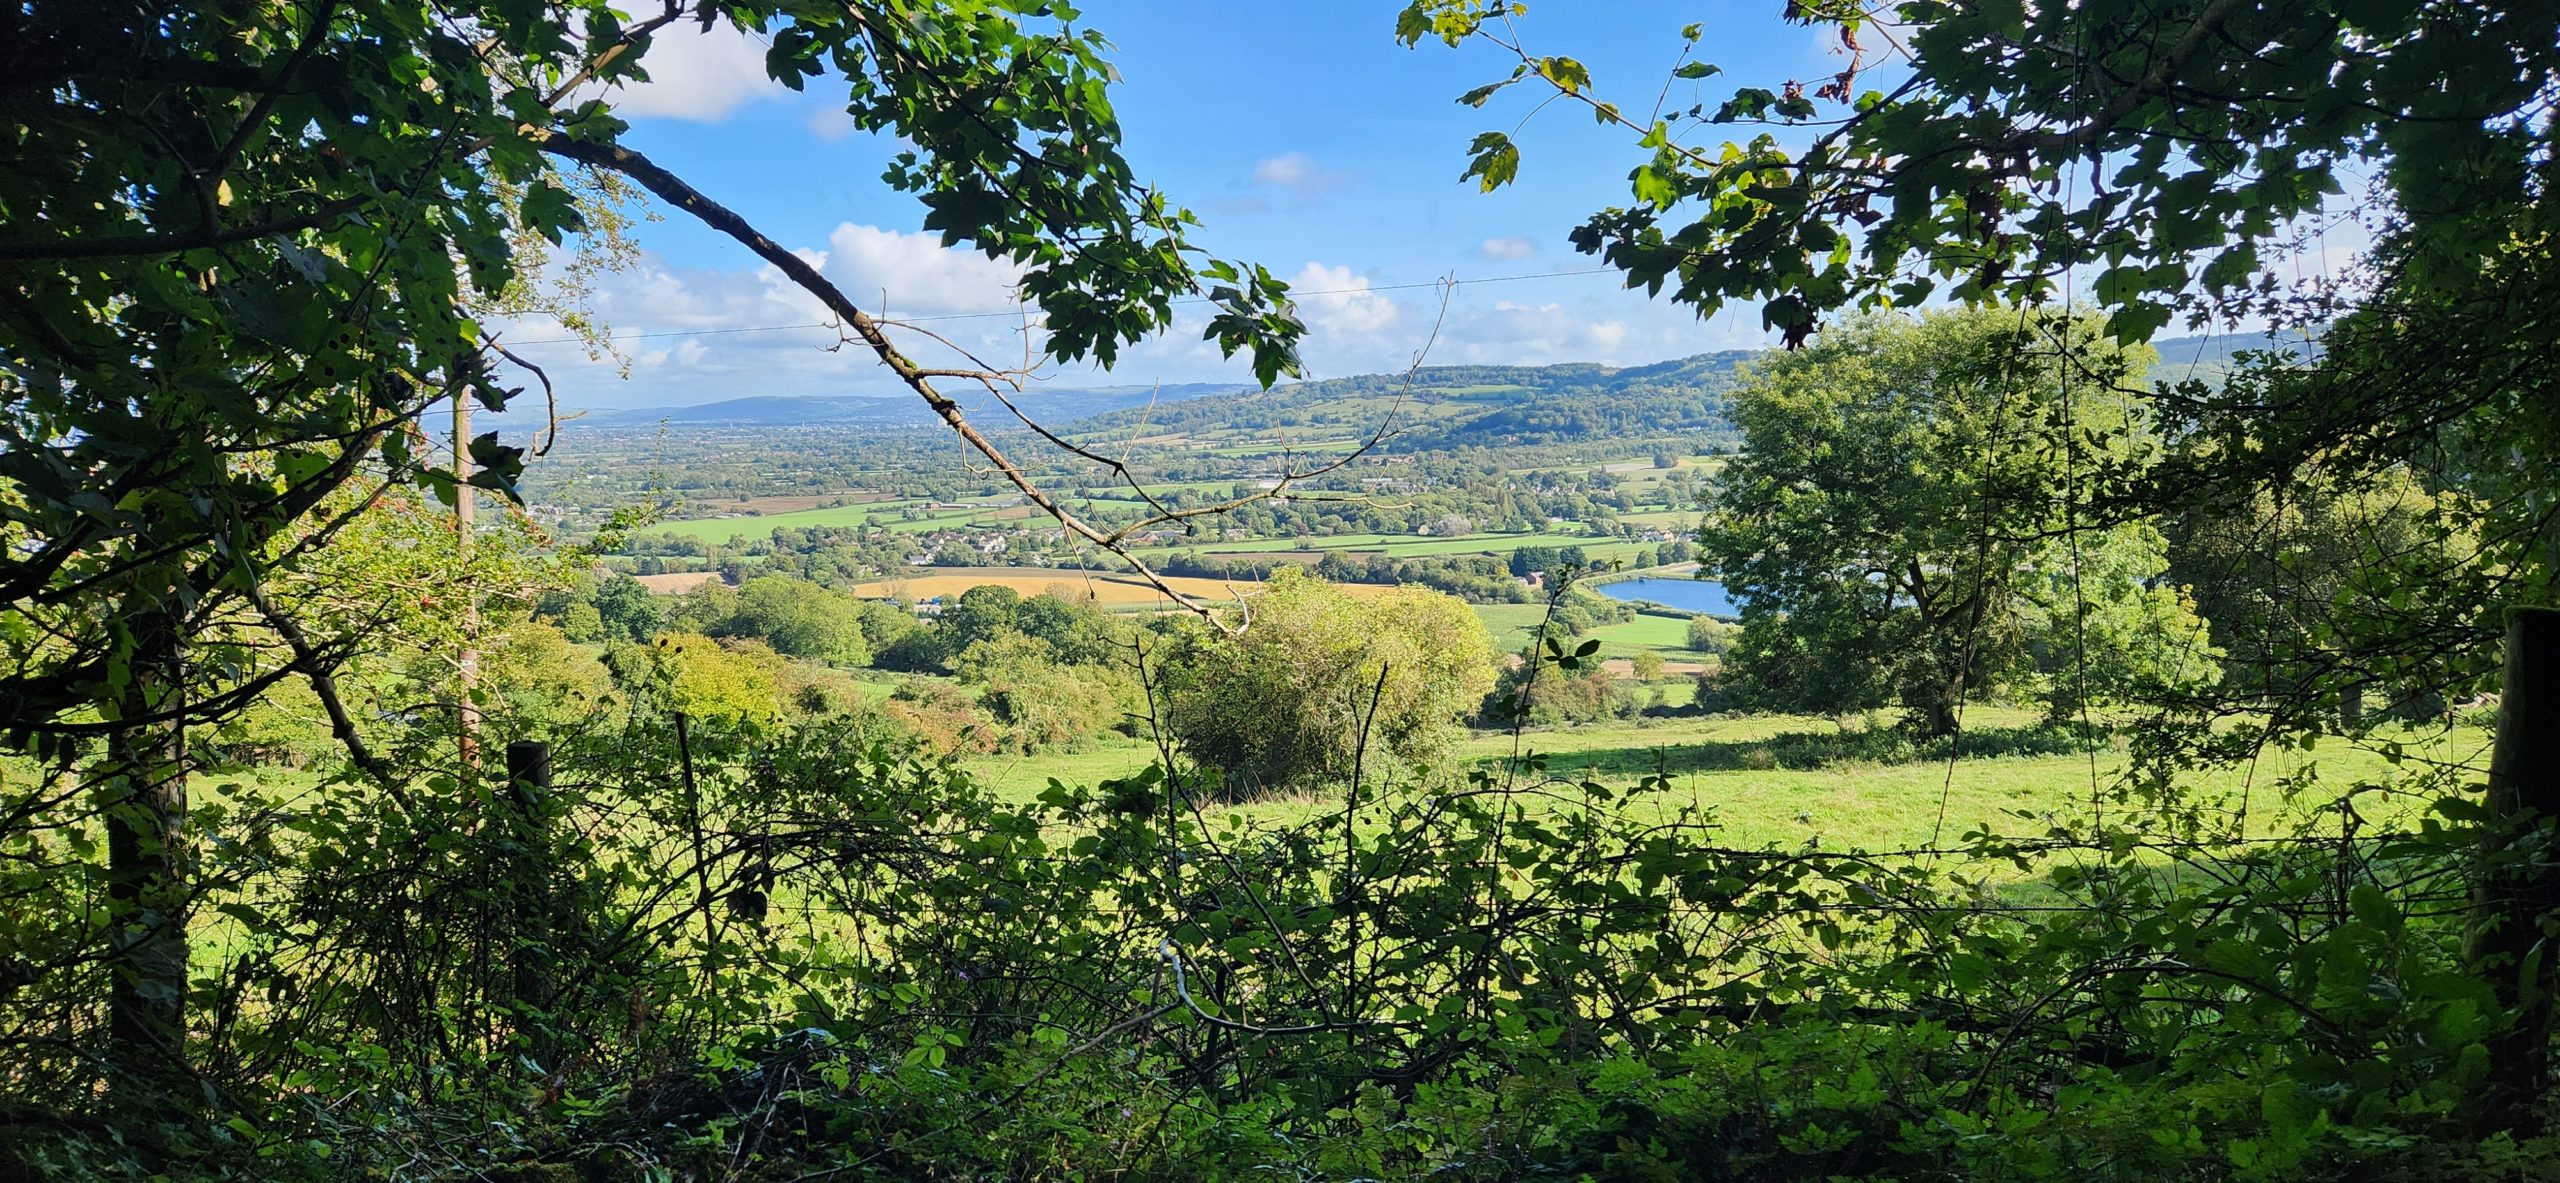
left=100, top=609, right=187, bottom=1111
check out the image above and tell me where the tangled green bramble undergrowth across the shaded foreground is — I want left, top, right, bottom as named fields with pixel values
left=8, top=699, right=2555, bottom=1183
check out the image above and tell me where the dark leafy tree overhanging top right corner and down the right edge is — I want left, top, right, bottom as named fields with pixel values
left=1398, top=0, right=2560, bottom=730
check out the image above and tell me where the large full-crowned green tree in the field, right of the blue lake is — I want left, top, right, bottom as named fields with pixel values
left=1700, top=310, right=2212, bottom=735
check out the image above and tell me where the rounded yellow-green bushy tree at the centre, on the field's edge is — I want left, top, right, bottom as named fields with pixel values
left=1165, top=568, right=1492, bottom=791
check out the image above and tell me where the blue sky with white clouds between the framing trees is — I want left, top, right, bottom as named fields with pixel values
left=509, top=0, right=1843, bottom=410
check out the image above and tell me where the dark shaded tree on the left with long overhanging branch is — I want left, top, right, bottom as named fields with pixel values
left=0, top=0, right=1298, bottom=1104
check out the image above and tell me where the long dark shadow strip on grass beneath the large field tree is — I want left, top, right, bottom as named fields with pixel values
left=1495, top=722, right=2107, bottom=776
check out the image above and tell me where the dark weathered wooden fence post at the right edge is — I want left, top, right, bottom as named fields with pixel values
left=2463, top=607, right=2560, bottom=1129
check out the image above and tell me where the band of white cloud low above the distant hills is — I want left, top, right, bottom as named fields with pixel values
left=481, top=235, right=1769, bottom=407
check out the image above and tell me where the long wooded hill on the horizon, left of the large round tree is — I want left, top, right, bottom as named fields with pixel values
left=1075, top=351, right=1756, bottom=451
